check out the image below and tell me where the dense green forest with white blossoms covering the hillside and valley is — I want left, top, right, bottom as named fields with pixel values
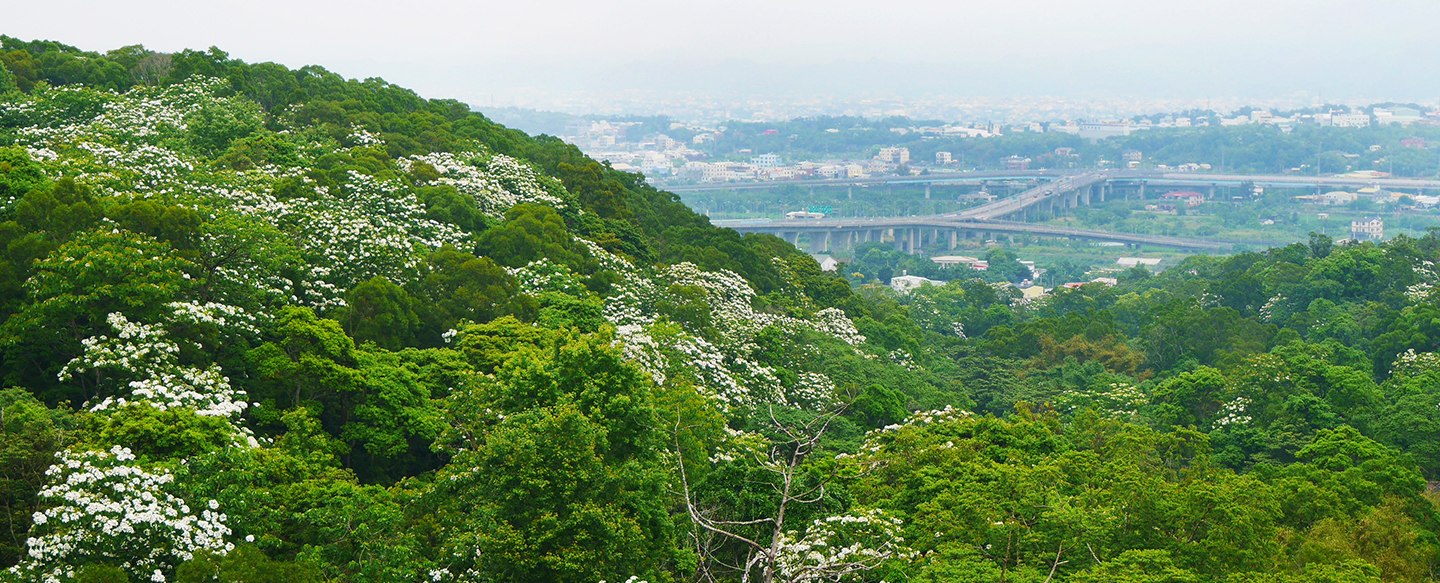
left=0, top=37, right=1440, bottom=583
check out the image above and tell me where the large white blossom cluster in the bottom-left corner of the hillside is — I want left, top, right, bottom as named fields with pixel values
left=10, top=446, right=233, bottom=583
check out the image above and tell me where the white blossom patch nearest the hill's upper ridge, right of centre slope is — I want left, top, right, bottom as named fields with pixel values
left=397, top=153, right=564, bottom=219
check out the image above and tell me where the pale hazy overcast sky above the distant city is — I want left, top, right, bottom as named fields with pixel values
left=0, top=0, right=1440, bottom=104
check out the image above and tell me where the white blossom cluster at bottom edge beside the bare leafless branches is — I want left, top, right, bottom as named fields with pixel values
left=775, top=510, right=916, bottom=583
